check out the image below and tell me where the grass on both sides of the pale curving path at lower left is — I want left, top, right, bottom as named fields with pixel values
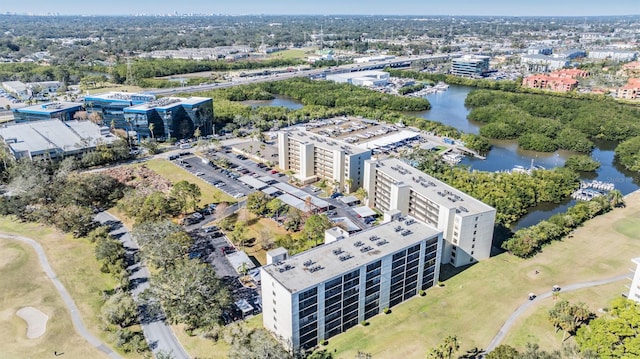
left=0, top=217, right=141, bottom=358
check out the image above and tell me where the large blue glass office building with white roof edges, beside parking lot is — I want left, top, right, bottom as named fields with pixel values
left=85, top=92, right=213, bottom=140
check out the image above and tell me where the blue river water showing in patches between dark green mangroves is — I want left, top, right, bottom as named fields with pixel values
left=247, top=85, right=640, bottom=230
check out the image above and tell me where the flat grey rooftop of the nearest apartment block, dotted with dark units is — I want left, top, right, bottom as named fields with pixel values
left=262, top=216, right=442, bottom=293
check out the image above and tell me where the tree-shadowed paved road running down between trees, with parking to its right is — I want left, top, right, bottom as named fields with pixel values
left=96, top=212, right=189, bottom=359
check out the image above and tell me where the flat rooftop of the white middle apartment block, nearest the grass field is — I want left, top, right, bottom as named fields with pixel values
left=374, top=158, right=495, bottom=217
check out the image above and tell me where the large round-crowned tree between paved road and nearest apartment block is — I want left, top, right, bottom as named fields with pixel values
left=150, top=258, right=231, bottom=330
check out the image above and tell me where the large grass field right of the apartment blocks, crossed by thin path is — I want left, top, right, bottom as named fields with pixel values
left=328, top=193, right=640, bottom=359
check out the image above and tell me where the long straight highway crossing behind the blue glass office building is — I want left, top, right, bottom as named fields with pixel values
left=146, top=54, right=457, bottom=96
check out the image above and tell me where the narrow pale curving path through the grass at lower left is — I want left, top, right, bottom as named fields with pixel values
left=0, top=233, right=121, bottom=358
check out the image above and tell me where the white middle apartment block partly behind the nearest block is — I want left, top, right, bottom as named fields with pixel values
left=363, top=158, right=496, bottom=267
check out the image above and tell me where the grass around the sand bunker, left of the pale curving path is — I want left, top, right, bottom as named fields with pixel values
left=0, top=239, right=106, bottom=358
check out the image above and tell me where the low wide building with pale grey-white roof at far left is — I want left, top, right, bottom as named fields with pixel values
left=0, top=119, right=117, bottom=160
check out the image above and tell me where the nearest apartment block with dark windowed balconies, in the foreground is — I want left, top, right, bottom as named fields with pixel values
left=260, top=216, right=442, bottom=348
